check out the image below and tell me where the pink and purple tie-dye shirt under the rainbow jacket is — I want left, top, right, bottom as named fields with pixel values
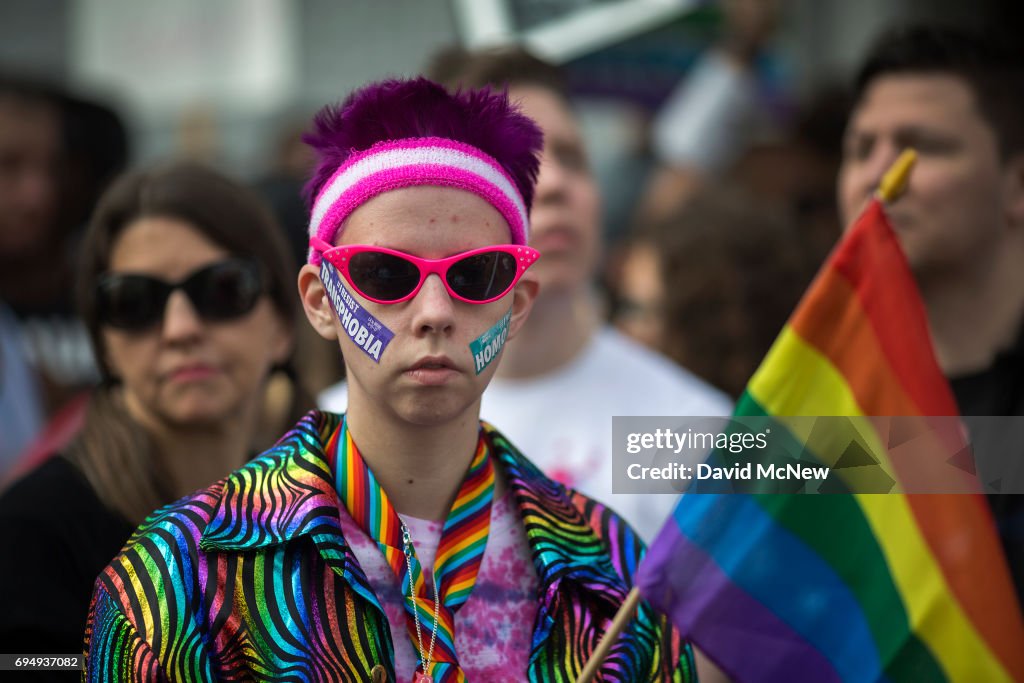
left=341, top=494, right=539, bottom=681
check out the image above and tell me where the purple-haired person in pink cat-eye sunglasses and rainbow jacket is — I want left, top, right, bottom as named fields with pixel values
left=86, top=79, right=692, bottom=683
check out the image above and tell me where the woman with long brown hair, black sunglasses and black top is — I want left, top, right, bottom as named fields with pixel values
left=0, top=158, right=311, bottom=654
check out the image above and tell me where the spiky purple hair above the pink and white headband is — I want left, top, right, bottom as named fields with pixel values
left=302, top=78, right=543, bottom=211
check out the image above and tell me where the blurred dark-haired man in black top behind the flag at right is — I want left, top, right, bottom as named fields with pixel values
left=839, top=27, right=1024, bottom=606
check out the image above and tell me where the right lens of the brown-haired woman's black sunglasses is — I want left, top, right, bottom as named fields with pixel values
left=181, top=261, right=263, bottom=321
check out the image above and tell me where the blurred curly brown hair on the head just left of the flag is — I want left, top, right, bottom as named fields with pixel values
left=630, top=185, right=809, bottom=397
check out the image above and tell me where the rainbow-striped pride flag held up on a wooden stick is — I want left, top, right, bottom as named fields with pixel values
left=637, top=169, right=1024, bottom=683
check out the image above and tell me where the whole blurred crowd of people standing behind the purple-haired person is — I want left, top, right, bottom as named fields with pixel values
left=0, top=2, right=1024, bottom=663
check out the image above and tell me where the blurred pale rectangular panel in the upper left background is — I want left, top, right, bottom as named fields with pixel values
left=70, top=0, right=299, bottom=118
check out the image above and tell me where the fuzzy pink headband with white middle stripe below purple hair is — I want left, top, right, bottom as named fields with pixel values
left=309, top=137, right=529, bottom=264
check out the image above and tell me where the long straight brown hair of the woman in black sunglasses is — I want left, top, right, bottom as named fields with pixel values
left=68, top=163, right=312, bottom=523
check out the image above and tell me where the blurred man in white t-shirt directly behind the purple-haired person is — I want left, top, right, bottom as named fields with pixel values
left=321, top=51, right=730, bottom=542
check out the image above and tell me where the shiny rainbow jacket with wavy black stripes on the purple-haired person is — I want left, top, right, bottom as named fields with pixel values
left=85, top=412, right=696, bottom=682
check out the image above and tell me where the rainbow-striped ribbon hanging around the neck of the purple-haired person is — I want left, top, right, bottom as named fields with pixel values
left=326, top=419, right=495, bottom=683
